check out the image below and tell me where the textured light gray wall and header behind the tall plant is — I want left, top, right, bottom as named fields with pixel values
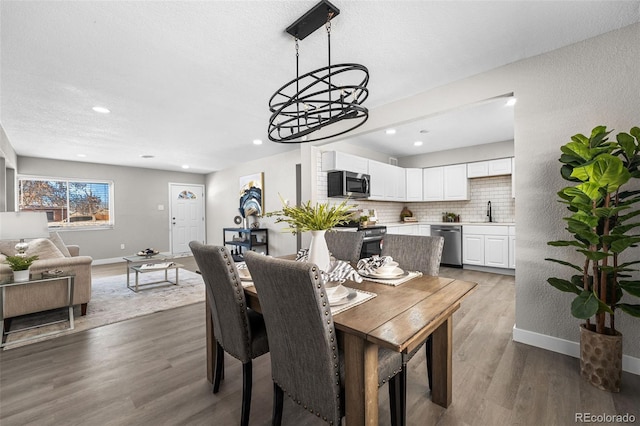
left=308, top=24, right=640, bottom=358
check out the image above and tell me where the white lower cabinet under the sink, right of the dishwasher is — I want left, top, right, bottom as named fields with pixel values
left=462, top=225, right=515, bottom=268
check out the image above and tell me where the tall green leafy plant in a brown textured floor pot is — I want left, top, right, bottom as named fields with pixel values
left=546, top=126, right=640, bottom=392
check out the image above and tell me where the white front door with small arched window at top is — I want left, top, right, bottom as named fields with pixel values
left=169, top=183, right=205, bottom=254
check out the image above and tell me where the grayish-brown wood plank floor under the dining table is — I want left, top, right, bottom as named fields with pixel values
left=0, top=258, right=640, bottom=426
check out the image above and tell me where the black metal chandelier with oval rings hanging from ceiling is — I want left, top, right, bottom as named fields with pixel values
left=269, top=0, right=369, bottom=143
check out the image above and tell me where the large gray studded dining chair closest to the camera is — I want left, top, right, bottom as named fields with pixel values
left=245, top=252, right=405, bottom=426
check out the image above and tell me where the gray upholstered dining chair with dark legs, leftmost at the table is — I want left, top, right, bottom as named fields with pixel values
left=189, top=241, right=269, bottom=426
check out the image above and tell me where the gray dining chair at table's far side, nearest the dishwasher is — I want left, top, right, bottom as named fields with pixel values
left=381, top=234, right=444, bottom=422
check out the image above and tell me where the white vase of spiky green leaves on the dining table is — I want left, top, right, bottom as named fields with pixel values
left=266, top=197, right=356, bottom=271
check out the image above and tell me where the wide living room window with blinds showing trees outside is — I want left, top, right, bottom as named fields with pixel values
left=18, top=177, right=113, bottom=229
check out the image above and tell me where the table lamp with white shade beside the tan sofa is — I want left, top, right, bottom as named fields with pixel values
left=0, top=212, right=49, bottom=257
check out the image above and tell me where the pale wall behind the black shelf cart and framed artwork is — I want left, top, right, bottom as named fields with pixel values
left=206, top=148, right=302, bottom=256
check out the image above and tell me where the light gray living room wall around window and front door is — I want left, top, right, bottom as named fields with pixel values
left=18, top=157, right=205, bottom=260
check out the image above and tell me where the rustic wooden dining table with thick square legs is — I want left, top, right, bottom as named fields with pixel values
left=206, top=276, right=477, bottom=426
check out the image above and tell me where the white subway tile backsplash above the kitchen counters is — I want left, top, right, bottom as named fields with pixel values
left=317, top=152, right=515, bottom=224
